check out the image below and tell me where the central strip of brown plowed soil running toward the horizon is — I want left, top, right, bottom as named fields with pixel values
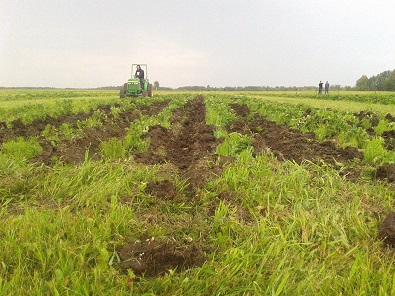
left=135, top=96, right=221, bottom=197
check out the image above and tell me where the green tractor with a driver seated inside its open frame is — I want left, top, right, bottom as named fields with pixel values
left=119, top=64, right=152, bottom=98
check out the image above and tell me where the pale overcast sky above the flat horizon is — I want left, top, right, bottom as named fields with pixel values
left=0, top=0, right=395, bottom=88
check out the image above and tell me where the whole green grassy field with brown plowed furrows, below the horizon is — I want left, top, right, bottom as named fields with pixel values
left=0, top=90, right=395, bottom=295
